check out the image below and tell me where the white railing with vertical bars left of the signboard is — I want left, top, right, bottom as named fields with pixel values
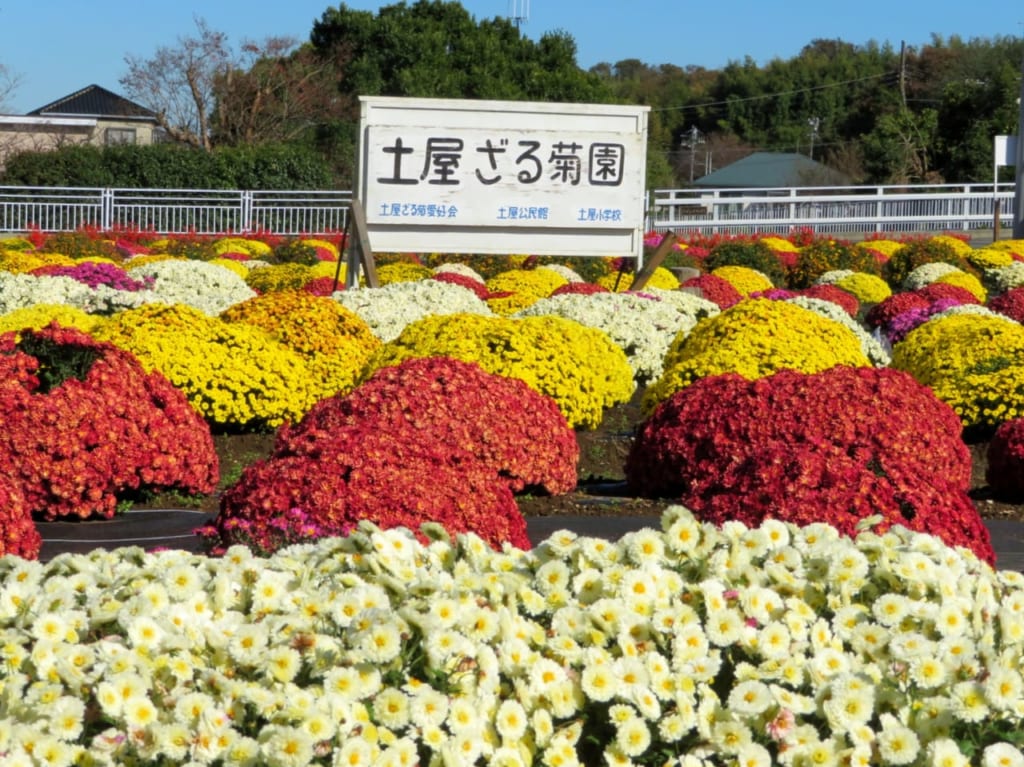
left=0, top=186, right=352, bottom=236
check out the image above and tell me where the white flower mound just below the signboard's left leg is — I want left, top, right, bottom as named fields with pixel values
left=333, top=280, right=494, bottom=343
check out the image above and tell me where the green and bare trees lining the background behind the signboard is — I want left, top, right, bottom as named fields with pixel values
left=0, top=0, right=1024, bottom=188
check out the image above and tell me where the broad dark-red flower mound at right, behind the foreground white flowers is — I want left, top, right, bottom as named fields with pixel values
left=626, top=367, right=995, bottom=562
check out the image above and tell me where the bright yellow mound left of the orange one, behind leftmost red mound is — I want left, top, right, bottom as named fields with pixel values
left=93, top=304, right=316, bottom=430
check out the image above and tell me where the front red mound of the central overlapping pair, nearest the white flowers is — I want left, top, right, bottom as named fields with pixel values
left=205, top=421, right=530, bottom=553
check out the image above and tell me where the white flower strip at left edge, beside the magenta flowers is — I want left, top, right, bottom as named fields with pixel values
left=0, top=271, right=158, bottom=314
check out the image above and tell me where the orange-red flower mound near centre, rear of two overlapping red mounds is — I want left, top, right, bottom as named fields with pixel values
left=274, top=357, right=580, bottom=495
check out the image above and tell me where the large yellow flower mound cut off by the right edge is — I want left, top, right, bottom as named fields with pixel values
left=892, top=312, right=1024, bottom=427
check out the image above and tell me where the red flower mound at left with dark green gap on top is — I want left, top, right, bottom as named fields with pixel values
left=0, top=325, right=219, bottom=519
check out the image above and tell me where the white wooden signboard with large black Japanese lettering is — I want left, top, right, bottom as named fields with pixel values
left=357, top=96, right=649, bottom=256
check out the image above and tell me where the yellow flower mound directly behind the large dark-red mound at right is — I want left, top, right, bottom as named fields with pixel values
left=642, top=298, right=871, bottom=415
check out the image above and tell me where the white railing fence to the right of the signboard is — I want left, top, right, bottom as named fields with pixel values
left=647, top=183, right=1015, bottom=236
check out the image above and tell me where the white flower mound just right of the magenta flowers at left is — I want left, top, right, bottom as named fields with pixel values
left=128, top=259, right=256, bottom=316
